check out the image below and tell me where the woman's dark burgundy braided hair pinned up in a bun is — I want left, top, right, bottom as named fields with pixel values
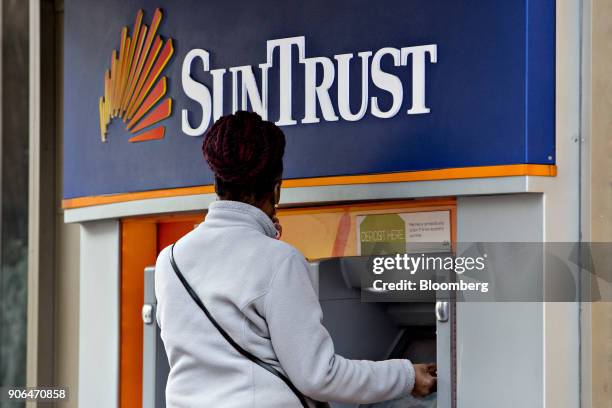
left=202, top=111, right=285, bottom=184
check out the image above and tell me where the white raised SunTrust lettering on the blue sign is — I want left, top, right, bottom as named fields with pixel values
left=181, top=36, right=437, bottom=136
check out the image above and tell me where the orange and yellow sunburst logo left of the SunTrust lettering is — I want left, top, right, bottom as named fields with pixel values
left=99, top=9, right=174, bottom=143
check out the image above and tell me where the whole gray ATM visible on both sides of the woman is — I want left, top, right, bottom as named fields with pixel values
left=142, top=256, right=456, bottom=408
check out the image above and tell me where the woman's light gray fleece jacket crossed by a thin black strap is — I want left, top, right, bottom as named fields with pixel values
left=155, top=201, right=414, bottom=408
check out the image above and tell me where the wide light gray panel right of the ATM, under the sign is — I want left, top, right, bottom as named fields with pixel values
left=457, top=194, right=544, bottom=408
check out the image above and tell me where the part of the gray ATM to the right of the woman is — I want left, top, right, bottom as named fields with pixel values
left=311, top=256, right=454, bottom=408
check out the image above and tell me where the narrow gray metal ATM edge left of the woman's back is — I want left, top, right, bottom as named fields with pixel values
left=142, top=266, right=170, bottom=408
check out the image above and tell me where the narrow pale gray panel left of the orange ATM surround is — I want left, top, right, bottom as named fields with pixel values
left=78, top=221, right=120, bottom=408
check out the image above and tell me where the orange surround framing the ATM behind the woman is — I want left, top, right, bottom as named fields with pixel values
left=119, top=198, right=456, bottom=408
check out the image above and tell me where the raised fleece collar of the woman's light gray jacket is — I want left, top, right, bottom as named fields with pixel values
left=206, top=200, right=276, bottom=238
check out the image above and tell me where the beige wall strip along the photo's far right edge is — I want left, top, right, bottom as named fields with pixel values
left=583, top=0, right=612, bottom=408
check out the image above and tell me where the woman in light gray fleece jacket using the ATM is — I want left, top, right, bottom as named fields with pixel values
left=155, top=112, right=435, bottom=408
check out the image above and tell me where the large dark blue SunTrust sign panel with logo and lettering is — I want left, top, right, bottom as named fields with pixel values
left=64, top=0, right=555, bottom=198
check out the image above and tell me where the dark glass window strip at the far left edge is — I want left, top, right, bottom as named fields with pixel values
left=0, top=1, right=29, bottom=408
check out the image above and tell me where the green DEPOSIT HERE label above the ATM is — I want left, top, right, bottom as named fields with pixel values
left=359, top=214, right=406, bottom=255
